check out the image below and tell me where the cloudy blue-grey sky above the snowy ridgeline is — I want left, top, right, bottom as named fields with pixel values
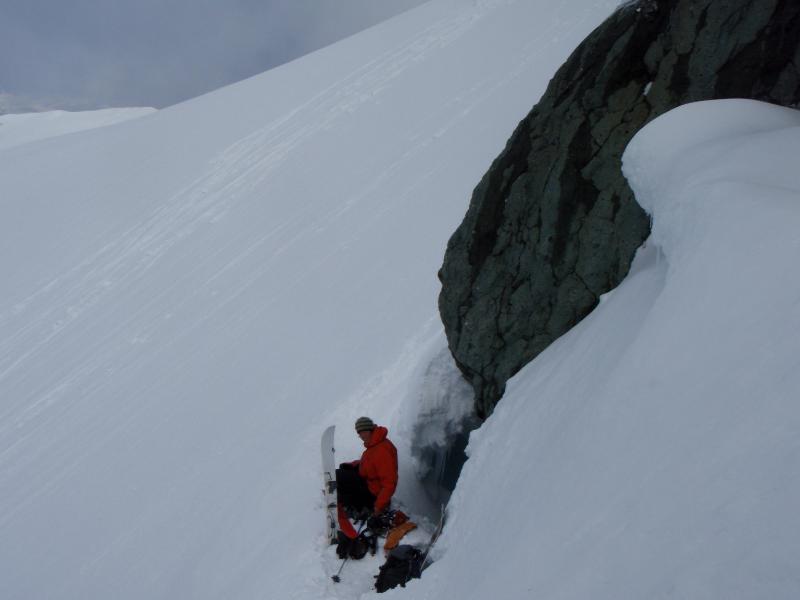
left=0, top=0, right=425, bottom=113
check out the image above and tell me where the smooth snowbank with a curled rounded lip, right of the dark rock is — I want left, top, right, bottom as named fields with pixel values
left=410, top=100, right=800, bottom=600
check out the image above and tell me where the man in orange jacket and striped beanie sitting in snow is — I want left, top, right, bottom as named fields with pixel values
left=336, top=417, right=397, bottom=537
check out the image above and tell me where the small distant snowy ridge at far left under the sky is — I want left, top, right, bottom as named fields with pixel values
left=0, top=108, right=155, bottom=150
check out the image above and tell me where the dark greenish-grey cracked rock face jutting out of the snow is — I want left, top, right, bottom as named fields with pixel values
left=439, top=0, right=800, bottom=416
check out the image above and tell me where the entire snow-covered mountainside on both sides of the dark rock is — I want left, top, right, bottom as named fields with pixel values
left=0, top=0, right=800, bottom=600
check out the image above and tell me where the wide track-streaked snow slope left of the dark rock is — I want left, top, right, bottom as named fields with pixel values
left=0, top=0, right=617, bottom=600
